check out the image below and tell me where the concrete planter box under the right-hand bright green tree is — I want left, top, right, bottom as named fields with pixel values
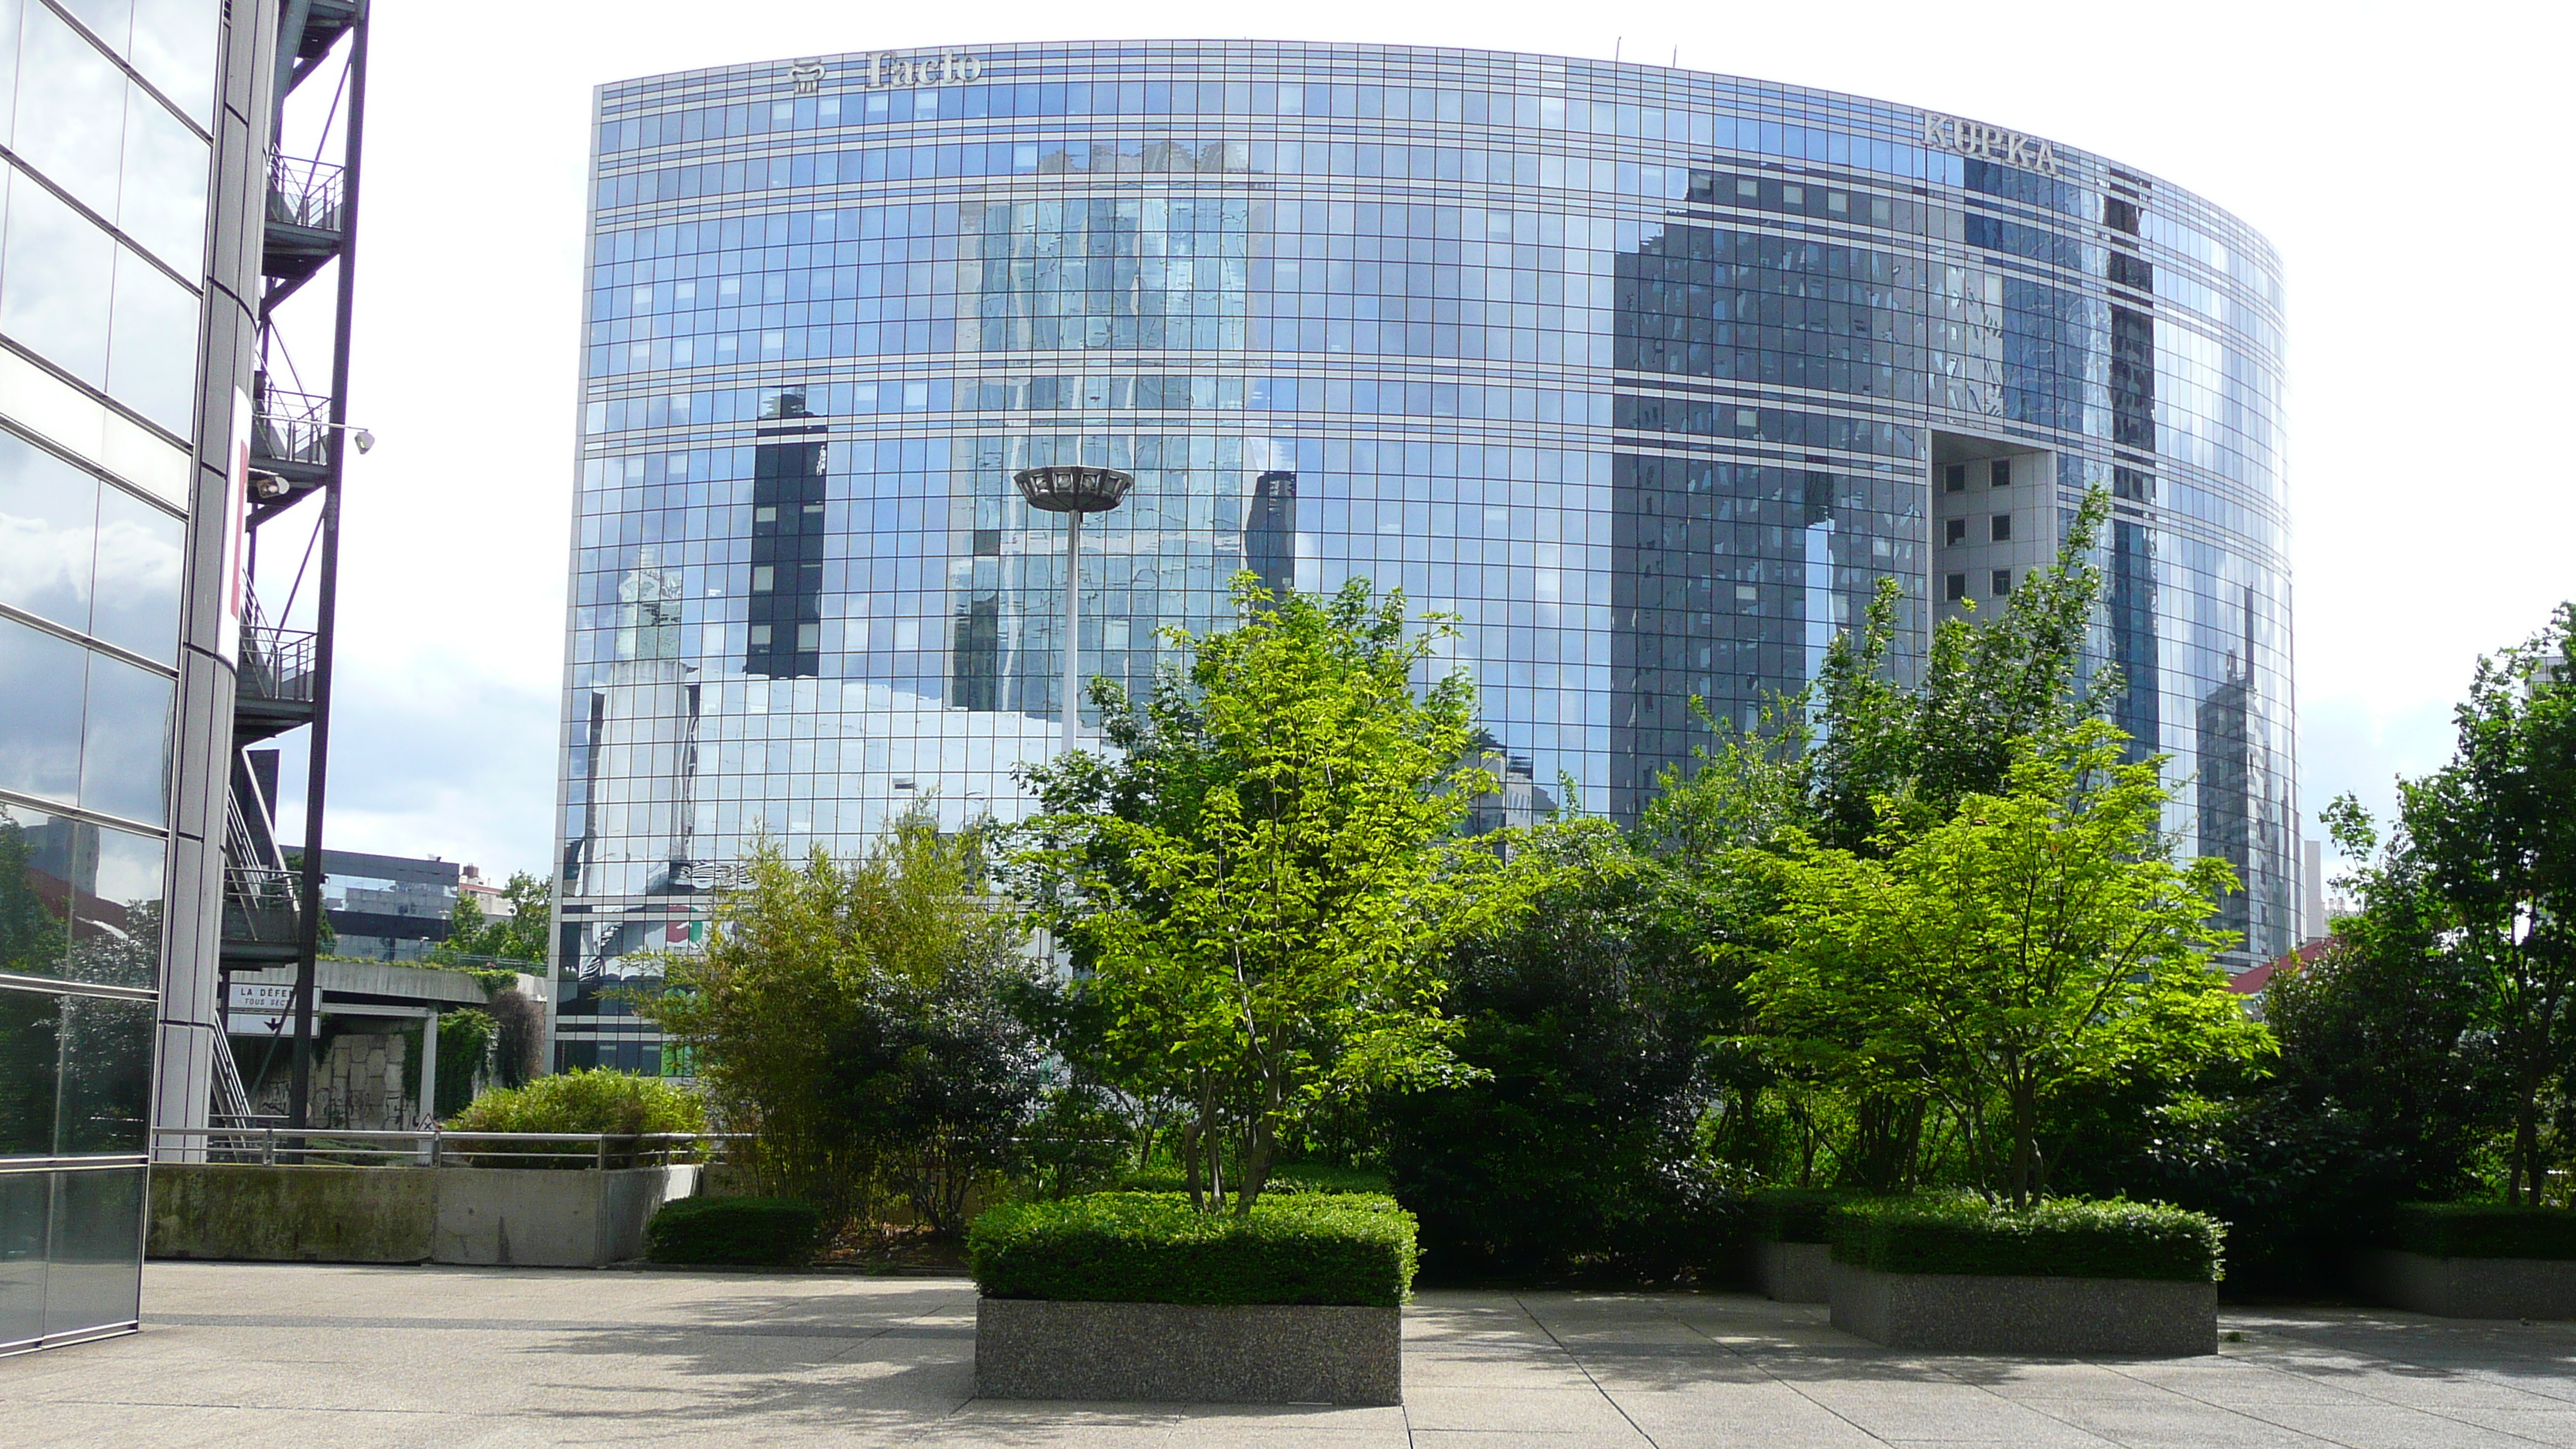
left=1829, top=1263, right=2218, bottom=1358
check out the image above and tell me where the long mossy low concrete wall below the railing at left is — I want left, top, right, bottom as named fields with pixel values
left=147, top=1163, right=698, bottom=1269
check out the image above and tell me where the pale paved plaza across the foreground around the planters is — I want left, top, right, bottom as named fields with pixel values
left=0, top=1263, right=2576, bottom=1449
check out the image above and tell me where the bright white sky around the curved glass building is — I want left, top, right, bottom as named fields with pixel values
left=262, top=0, right=2576, bottom=874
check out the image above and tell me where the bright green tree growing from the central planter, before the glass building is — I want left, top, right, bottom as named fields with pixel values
left=1012, top=572, right=1499, bottom=1214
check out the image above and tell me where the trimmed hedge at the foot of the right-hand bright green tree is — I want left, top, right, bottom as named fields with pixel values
left=1827, top=1197, right=2225, bottom=1284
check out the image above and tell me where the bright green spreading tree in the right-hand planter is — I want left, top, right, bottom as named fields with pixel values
left=1746, top=722, right=2269, bottom=1207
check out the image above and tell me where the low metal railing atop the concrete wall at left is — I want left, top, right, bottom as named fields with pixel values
left=152, top=1124, right=749, bottom=1170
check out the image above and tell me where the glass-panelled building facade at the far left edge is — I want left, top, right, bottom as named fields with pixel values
left=0, top=0, right=276, bottom=1354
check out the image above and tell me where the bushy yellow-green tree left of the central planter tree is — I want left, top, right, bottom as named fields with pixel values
left=639, top=807, right=1043, bottom=1230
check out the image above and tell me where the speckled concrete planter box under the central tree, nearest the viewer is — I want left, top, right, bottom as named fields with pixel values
left=974, top=1297, right=1404, bottom=1403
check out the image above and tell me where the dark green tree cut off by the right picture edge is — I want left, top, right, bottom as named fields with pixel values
left=2398, top=603, right=2576, bottom=1201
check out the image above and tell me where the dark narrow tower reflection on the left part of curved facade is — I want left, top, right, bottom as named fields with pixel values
left=742, top=392, right=827, bottom=678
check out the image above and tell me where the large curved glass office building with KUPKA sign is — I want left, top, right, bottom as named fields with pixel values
left=559, top=41, right=2298, bottom=1067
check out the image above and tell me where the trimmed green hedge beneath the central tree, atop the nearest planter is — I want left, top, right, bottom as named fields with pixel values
left=966, top=1191, right=1414, bottom=1307
